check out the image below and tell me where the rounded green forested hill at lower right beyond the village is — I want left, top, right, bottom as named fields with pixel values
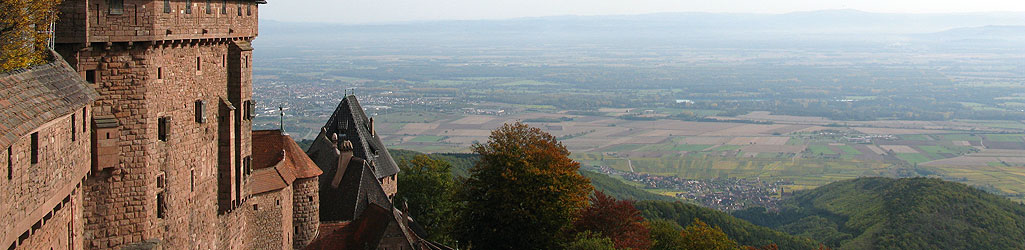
left=734, top=177, right=1025, bottom=249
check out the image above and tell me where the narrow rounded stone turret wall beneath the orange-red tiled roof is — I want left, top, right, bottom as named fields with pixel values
left=292, top=177, right=320, bottom=249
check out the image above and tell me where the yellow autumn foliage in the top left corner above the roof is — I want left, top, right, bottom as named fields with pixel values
left=0, top=0, right=60, bottom=72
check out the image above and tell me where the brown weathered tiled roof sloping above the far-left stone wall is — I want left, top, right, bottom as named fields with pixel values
left=0, top=51, right=99, bottom=148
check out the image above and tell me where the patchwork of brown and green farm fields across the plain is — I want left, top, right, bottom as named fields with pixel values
left=378, top=107, right=1025, bottom=200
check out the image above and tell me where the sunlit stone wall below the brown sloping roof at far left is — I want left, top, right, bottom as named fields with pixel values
left=0, top=107, right=91, bottom=249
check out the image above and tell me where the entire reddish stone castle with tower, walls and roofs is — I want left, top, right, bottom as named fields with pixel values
left=0, top=0, right=448, bottom=249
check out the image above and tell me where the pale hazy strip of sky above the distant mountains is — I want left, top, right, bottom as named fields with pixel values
left=260, top=0, right=1025, bottom=24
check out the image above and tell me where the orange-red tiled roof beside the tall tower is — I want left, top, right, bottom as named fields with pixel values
left=252, top=130, right=324, bottom=194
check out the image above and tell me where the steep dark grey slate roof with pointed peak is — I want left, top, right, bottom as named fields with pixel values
left=319, top=95, right=399, bottom=179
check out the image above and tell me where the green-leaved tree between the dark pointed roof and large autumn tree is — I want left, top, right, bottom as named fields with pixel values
left=395, top=155, right=455, bottom=244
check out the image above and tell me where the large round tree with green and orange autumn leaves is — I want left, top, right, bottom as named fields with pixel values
left=455, top=122, right=592, bottom=249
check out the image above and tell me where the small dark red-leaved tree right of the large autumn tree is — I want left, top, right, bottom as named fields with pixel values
left=573, top=191, right=651, bottom=249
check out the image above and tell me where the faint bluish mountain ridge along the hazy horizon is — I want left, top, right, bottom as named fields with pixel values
left=256, top=9, right=1025, bottom=47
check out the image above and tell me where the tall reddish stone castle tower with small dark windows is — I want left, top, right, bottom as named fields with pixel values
left=55, top=0, right=263, bottom=246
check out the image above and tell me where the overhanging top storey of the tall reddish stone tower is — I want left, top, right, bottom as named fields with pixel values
left=54, top=0, right=262, bottom=43
